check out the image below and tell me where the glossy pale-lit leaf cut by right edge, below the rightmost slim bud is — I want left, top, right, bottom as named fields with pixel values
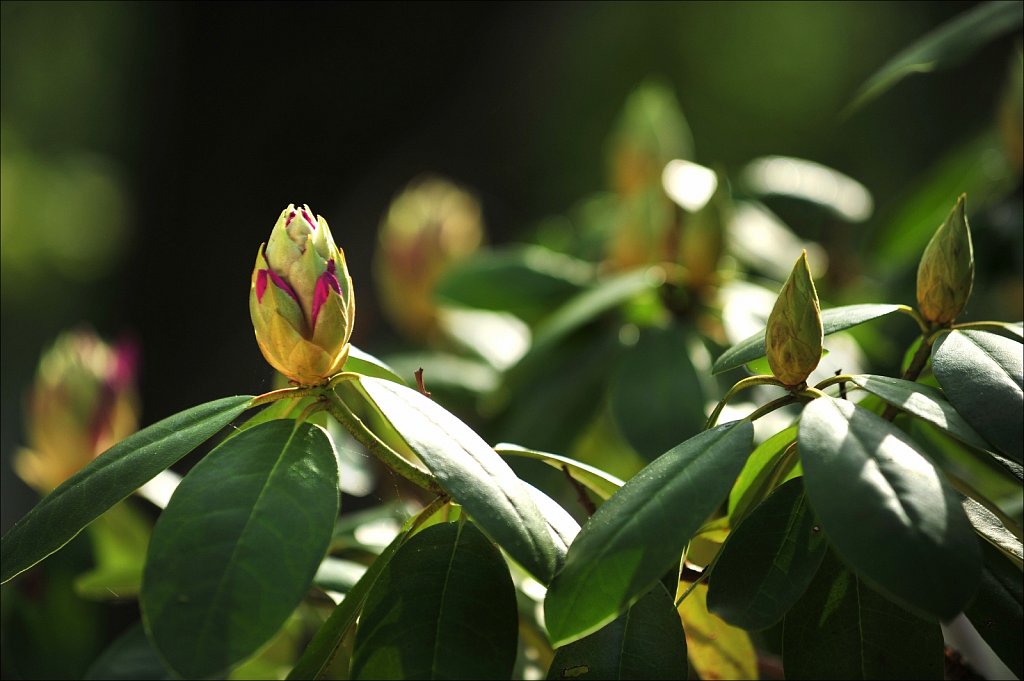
left=932, top=331, right=1024, bottom=463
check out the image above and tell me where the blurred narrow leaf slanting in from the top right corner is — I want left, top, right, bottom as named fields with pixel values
left=849, top=1, right=1022, bottom=110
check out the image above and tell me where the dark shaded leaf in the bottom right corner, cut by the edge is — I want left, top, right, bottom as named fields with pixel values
left=964, top=545, right=1024, bottom=679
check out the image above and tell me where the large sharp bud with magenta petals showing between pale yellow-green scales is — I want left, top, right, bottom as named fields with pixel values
left=249, top=205, right=355, bottom=385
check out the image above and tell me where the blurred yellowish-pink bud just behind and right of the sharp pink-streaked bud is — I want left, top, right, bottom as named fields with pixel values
left=374, top=178, right=483, bottom=341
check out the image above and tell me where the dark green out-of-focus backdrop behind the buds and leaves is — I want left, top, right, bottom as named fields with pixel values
left=0, top=2, right=1022, bottom=675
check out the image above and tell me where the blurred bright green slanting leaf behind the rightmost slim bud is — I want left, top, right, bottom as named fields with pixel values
left=871, top=129, right=1017, bottom=270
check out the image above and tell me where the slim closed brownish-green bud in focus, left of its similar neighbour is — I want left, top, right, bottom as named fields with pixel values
left=765, top=251, right=823, bottom=386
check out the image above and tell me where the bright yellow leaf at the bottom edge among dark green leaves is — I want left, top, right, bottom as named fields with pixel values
left=676, top=582, right=758, bottom=679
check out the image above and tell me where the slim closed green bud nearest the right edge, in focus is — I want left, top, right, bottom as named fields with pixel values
left=918, top=194, right=974, bottom=324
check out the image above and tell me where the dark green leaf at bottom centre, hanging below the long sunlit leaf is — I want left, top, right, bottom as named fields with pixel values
left=352, top=522, right=518, bottom=679
